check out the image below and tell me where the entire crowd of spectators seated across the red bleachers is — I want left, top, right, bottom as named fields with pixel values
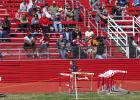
left=0, top=0, right=139, bottom=59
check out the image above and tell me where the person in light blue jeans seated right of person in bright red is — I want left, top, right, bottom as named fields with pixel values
left=53, top=13, right=62, bottom=32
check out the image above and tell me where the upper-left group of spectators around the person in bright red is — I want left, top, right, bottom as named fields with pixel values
left=15, top=0, right=79, bottom=32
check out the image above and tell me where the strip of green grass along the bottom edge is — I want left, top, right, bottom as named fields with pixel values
left=0, top=92, right=140, bottom=100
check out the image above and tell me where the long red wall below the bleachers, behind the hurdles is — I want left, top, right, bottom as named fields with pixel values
left=0, top=59, right=140, bottom=83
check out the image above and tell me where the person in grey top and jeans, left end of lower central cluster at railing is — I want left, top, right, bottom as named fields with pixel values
left=56, top=35, right=67, bottom=59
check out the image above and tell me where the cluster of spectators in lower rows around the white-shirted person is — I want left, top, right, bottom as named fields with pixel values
left=56, top=26, right=106, bottom=59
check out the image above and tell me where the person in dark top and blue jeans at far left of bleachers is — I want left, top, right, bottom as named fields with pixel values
left=2, top=16, right=11, bottom=42
